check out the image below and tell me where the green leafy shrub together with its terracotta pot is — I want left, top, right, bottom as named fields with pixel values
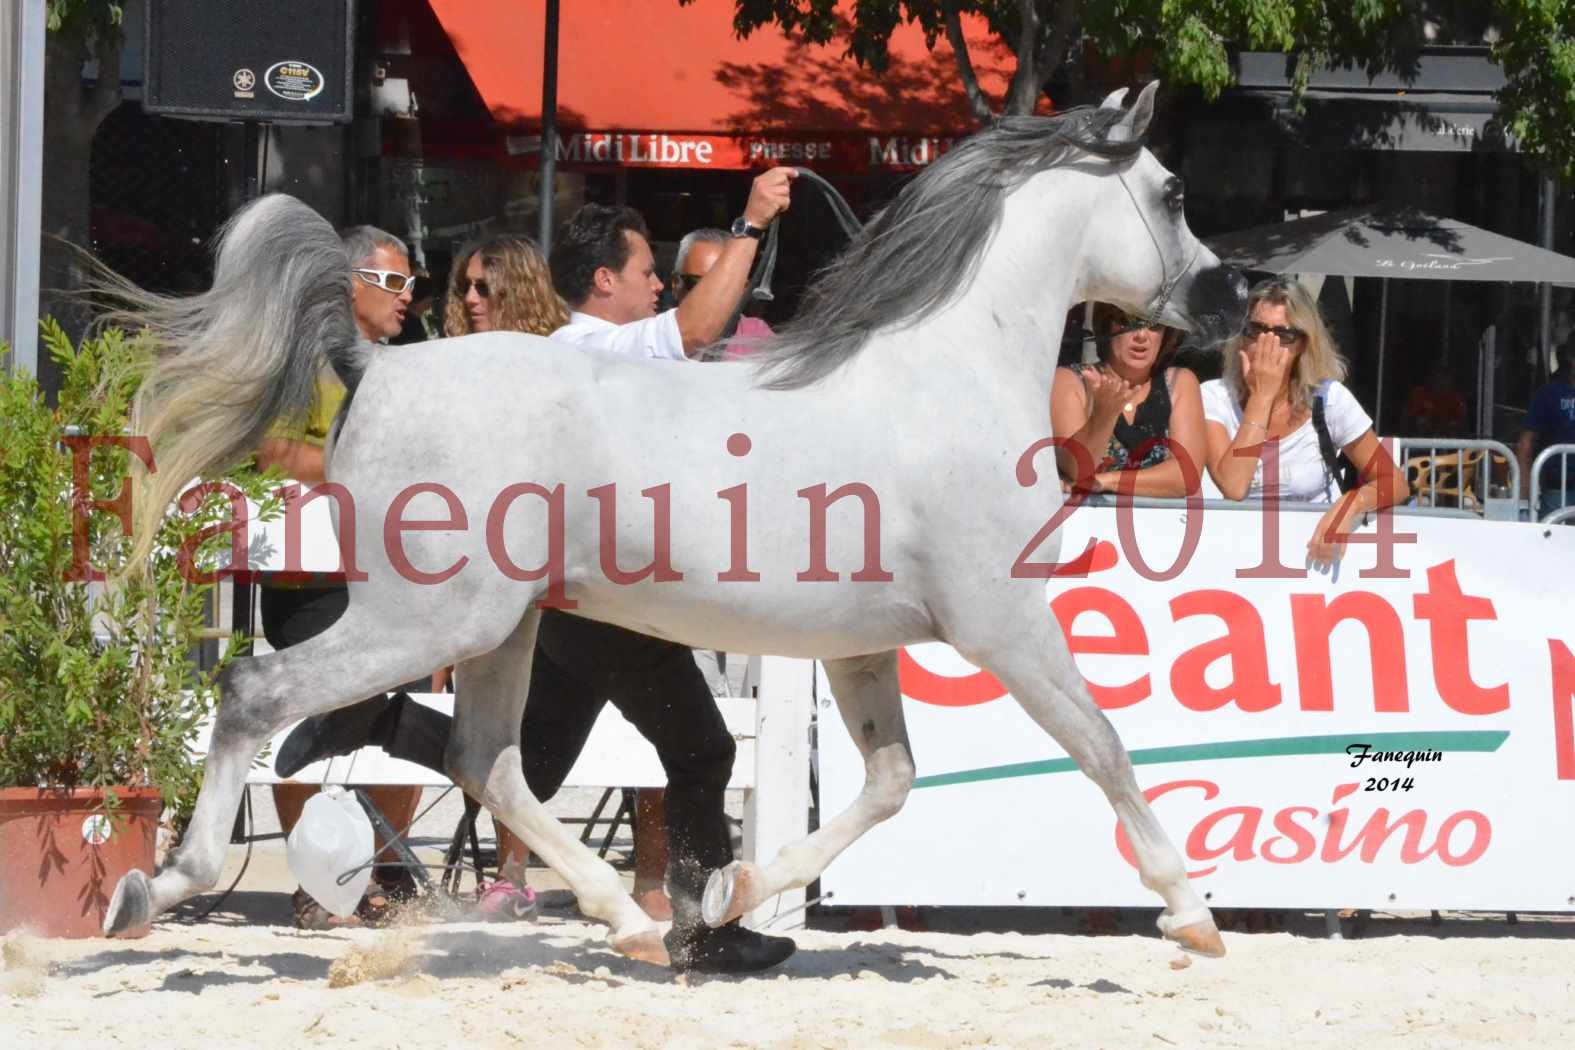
left=0, top=320, right=277, bottom=937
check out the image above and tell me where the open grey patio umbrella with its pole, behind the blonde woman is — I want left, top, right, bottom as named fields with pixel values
left=1208, top=205, right=1575, bottom=425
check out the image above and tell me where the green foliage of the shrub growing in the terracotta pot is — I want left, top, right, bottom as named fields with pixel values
left=0, top=318, right=280, bottom=803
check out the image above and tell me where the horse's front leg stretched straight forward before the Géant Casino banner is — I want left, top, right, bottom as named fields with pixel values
left=953, top=601, right=1225, bottom=956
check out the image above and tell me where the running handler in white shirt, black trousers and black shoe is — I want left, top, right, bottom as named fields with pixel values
left=535, top=168, right=795, bottom=973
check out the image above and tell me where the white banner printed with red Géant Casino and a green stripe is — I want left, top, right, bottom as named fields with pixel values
left=821, top=508, right=1575, bottom=911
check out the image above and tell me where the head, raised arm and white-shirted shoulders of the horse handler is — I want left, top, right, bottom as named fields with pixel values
left=551, top=167, right=797, bottom=360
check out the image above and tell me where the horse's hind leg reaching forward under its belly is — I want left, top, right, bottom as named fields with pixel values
left=446, top=609, right=668, bottom=965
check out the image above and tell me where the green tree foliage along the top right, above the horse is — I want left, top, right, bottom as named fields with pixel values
left=696, top=0, right=1575, bottom=181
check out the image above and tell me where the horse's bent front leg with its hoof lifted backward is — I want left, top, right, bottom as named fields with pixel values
left=704, top=652, right=914, bottom=926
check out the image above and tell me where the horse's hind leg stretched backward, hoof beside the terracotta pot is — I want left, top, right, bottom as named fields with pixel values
left=104, top=604, right=452, bottom=937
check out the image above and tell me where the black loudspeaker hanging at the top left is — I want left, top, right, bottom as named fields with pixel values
left=142, top=0, right=356, bottom=124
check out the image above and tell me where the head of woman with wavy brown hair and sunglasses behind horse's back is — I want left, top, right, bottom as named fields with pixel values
left=443, top=235, right=569, bottom=335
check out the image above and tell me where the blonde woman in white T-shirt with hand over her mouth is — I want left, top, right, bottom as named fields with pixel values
left=1202, top=279, right=1408, bottom=567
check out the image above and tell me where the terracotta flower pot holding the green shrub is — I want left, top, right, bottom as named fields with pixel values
left=0, top=787, right=164, bottom=937
